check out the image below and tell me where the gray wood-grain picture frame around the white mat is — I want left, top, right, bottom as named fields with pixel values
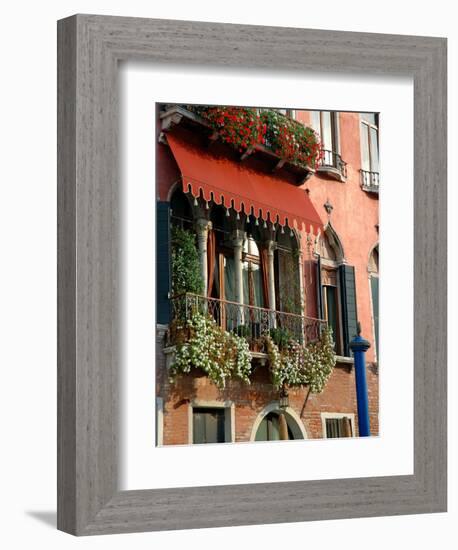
left=58, top=15, right=447, bottom=535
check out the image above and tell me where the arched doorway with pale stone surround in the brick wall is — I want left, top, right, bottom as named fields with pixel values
left=250, top=401, right=307, bottom=441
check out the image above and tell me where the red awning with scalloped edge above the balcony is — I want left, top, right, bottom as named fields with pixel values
left=167, top=134, right=322, bottom=234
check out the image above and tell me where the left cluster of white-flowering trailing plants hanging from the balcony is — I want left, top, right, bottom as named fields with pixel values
left=169, top=312, right=251, bottom=389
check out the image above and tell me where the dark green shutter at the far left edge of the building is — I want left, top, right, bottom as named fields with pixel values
left=156, top=201, right=171, bottom=325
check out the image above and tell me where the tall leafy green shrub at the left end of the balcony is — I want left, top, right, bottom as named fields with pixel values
left=172, top=226, right=203, bottom=296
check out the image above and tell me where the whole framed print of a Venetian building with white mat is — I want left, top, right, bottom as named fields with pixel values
left=58, top=15, right=446, bottom=535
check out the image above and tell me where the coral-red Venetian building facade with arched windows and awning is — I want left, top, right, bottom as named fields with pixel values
left=156, top=105, right=380, bottom=445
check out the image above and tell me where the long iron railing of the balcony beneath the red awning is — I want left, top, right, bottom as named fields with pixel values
left=169, top=293, right=326, bottom=351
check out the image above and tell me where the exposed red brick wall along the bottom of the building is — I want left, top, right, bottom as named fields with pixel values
left=156, top=342, right=379, bottom=445
